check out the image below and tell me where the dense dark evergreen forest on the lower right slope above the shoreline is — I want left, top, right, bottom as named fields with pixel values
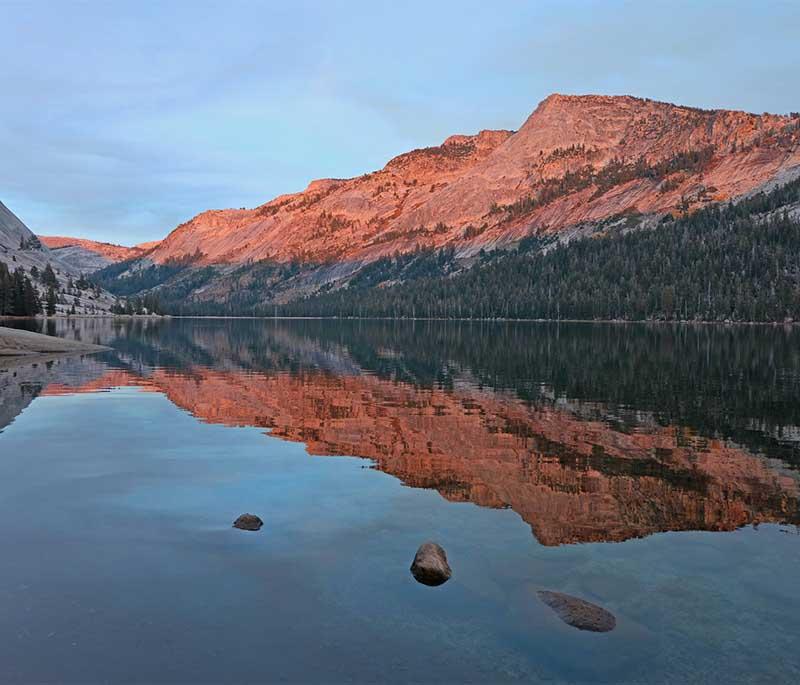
left=280, top=179, right=800, bottom=321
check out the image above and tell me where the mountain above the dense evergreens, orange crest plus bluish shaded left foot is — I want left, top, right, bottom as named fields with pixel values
left=90, top=94, right=800, bottom=320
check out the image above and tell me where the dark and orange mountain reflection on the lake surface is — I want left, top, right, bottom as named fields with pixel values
left=0, top=320, right=800, bottom=545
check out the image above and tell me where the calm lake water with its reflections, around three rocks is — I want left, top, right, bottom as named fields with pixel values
left=0, top=319, right=800, bottom=683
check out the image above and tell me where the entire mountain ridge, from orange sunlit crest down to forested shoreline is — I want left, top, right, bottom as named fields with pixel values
left=51, top=94, right=800, bottom=321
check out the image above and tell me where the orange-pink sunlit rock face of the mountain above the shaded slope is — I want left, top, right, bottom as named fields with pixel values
left=144, top=95, right=800, bottom=263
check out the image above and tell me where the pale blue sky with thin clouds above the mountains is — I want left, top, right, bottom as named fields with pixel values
left=0, top=0, right=800, bottom=244
